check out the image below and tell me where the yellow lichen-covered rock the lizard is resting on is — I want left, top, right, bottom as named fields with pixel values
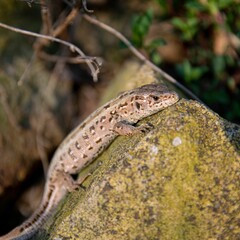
left=34, top=99, right=240, bottom=240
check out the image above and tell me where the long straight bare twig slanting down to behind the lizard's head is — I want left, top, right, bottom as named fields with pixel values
left=83, top=14, right=203, bottom=103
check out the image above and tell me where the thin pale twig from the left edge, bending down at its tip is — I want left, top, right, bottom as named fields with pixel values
left=0, top=23, right=99, bottom=81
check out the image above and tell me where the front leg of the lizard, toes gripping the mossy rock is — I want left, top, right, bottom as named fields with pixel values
left=112, top=121, right=153, bottom=136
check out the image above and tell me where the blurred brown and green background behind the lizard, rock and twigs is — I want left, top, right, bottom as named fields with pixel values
left=0, top=0, right=240, bottom=234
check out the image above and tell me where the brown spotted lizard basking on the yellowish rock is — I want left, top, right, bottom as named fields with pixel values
left=0, top=83, right=179, bottom=240
